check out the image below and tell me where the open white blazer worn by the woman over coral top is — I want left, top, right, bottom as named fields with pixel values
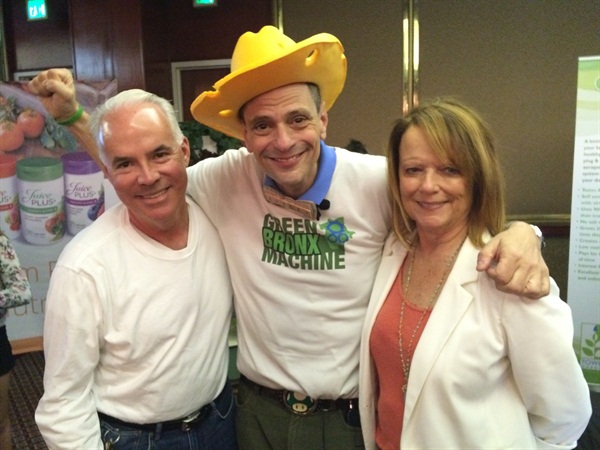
left=359, top=235, right=591, bottom=450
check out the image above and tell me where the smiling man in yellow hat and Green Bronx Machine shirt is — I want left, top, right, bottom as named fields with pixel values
left=29, top=26, right=548, bottom=450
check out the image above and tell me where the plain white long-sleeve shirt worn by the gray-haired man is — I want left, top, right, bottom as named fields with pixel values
left=36, top=202, right=232, bottom=449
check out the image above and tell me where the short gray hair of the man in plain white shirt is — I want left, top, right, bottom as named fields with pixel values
left=90, top=89, right=184, bottom=159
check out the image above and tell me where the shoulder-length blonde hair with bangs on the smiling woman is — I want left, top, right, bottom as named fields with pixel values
left=387, top=98, right=505, bottom=247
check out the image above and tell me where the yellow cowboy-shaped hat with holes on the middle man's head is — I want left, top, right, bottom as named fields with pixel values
left=191, top=25, right=346, bottom=139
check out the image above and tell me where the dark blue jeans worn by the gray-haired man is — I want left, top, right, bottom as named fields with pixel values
left=100, top=381, right=237, bottom=450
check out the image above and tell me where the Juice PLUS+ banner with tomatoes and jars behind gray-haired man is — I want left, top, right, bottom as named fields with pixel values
left=0, top=80, right=117, bottom=354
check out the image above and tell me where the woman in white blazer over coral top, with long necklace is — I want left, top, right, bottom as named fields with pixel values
left=359, top=100, right=591, bottom=450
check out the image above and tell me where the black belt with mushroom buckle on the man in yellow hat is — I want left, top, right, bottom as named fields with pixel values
left=240, top=375, right=358, bottom=415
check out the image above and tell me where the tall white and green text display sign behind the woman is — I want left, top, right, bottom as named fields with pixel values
left=568, top=56, right=600, bottom=391
